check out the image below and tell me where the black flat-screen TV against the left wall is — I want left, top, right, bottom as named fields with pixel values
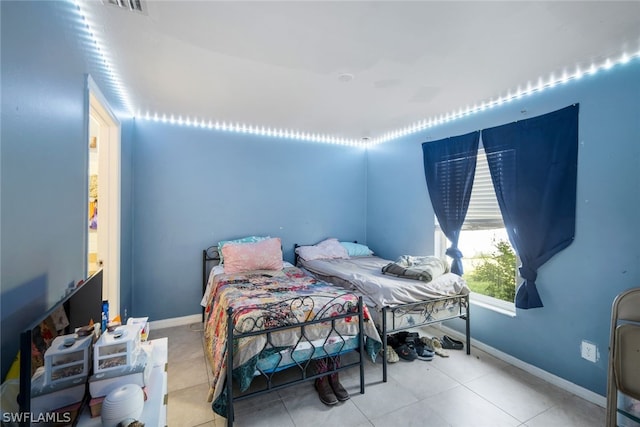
left=18, top=270, right=102, bottom=425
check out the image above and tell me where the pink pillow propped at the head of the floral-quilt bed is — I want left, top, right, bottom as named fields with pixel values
left=222, top=237, right=282, bottom=273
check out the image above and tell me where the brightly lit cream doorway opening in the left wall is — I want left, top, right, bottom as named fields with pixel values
left=86, top=77, right=120, bottom=318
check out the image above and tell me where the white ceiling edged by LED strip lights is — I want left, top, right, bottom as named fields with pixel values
left=83, top=0, right=640, bottom=139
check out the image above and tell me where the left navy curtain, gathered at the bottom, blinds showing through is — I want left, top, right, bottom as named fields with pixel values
left=422, top=131, right=480, bottom=275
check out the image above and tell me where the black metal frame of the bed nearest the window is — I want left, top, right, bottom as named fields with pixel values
left=293, top=242, right=471, bottom=382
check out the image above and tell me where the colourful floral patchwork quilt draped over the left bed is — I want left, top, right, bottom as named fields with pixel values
left=204, top=267, right=381, bottom=415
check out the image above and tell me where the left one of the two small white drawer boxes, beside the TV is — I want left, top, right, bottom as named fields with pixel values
left=44, top=334, right=93, bottom=385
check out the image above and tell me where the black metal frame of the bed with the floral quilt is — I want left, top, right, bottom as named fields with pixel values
left=202, top=246, right=365, bottom=427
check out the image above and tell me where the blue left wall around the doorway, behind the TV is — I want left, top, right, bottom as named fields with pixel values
left=0, top=1, right=131, bottom=378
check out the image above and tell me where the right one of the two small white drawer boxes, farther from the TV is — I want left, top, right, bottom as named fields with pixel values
left=93, top=325, right=140, bottom=374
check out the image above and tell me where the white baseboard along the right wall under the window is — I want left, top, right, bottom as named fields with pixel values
left=439, top=325, right=607, bottom=408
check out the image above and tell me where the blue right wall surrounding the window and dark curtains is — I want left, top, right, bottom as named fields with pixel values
left=367, top=59, right=640, bottom=395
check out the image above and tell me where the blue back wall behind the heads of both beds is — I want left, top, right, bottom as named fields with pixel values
left=133, top=121, right=366, bottom=320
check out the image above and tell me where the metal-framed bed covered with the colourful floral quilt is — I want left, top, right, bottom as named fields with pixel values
left=201, top=246, right=381, bottom=426
